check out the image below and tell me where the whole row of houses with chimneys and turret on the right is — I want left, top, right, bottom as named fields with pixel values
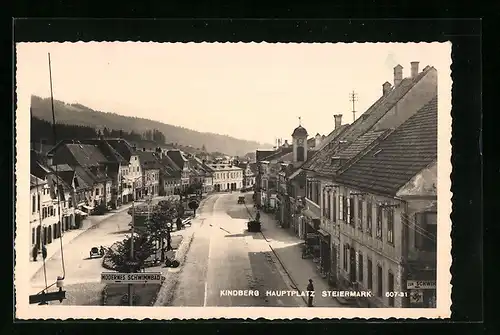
left=255, top=62, right=440, bottom=307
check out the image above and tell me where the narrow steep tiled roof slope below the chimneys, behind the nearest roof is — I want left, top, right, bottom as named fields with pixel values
left=304, top=67, right=434, bottom=175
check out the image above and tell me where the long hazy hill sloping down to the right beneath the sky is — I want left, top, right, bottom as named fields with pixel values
left=31, top=96, right=272, bottom=156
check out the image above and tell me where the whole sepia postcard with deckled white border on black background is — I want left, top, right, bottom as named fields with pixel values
left=15, top=42, right=452, bottom=319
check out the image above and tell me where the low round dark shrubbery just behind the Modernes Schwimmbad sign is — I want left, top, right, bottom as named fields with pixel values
left=107, top=235, right=154, bottom=272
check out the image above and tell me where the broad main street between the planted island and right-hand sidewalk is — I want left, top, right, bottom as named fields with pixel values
left=170, top=192, right=304, bottom=307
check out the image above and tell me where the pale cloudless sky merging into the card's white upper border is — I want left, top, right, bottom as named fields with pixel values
left=16, top=42, right=451, bottom=144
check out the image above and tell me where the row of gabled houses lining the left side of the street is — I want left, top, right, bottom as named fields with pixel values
left=30, top=137, right=255, bottom=258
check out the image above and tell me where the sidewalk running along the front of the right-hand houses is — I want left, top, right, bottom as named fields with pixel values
left=260, top=213, right=342, bottom=307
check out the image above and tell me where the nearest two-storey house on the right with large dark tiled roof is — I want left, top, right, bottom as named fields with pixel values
left=320, top=98, right=437, bottom=307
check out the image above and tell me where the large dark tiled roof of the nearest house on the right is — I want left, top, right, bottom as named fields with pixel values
left=337, top=98, right=437, bottom=195
